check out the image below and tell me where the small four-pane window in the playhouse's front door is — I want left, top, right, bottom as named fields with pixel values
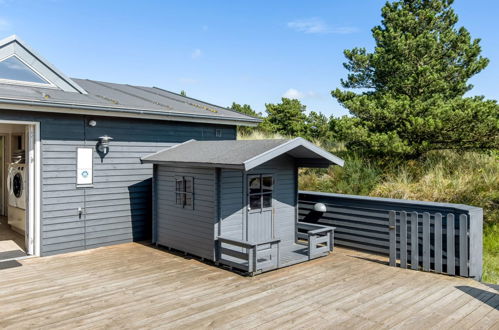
left=248, top=175, right=274, bottom=210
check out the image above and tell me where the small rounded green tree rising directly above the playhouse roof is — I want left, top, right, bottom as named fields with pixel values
left=262, top=97, right=307, bottom=136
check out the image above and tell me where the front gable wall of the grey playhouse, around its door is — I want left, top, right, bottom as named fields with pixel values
left=220, top=155, right=297, bottom=247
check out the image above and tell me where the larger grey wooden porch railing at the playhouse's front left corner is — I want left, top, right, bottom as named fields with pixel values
left=217, top=237, right=281, bottom=274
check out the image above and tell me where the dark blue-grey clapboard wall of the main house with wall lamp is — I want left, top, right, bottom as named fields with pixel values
left=0, top=110, right=236, bottom=255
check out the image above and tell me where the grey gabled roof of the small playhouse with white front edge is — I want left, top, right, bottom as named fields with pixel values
left=142, top=138, right=343, bottom=171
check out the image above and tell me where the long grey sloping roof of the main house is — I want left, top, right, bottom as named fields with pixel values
left=0, top=79, right=260, bottom=124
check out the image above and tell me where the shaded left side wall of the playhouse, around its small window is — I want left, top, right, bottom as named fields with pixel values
left=154, top=165, right=216, bottom=260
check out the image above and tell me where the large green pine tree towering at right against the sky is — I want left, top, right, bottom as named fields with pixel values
left=332, top=0, right=499, bottom=158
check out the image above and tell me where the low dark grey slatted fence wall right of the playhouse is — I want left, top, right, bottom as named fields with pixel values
left=299, top=191, right=483, bottom=279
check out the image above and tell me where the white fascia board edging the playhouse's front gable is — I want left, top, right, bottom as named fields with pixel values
left=244, top=137, right=344, bottom=171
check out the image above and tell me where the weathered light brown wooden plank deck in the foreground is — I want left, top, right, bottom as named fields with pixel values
left=0, top=243, right=499, bottom=329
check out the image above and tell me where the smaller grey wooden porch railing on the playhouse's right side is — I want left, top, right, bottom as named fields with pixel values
left=297, top=222, right=335, bottom=259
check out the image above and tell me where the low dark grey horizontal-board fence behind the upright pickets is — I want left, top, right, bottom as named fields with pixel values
left=299, top=191, right=483, bottom=280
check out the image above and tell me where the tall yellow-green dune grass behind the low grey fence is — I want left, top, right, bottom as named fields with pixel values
left=240, top=132, right=499, bottom=284
